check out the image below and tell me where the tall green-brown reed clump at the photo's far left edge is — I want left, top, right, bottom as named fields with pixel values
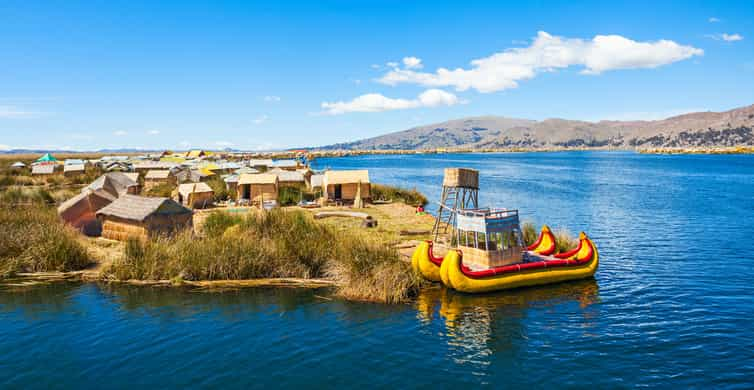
left=0, top=206, right=91, bottom=277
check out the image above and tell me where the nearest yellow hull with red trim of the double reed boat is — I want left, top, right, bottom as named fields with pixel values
left=440, top=232, right=599, bottom=293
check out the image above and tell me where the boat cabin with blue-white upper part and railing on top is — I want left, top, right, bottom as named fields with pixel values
left=454, top=208, right=525, bottom=269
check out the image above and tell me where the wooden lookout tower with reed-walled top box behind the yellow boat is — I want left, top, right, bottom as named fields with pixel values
left=432, top=168, right=479, bottom=242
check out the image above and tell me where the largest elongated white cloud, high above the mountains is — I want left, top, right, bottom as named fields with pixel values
left=378, top=31, right=704, bottom=93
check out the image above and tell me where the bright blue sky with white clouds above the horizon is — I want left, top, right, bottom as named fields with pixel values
left=0, top=0, right=754, bottom=150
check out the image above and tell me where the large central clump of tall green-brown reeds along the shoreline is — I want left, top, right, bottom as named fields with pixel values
left=110, top=210, right=419, bottom=303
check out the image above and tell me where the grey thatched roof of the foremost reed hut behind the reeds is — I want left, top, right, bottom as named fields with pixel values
left=97, top=194, right=192, bottom=222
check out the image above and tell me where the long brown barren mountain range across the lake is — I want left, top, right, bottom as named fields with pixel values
left=320, top=105, right=754, bottom=150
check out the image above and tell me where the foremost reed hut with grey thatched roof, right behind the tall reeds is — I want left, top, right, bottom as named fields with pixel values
left=96, top=195, right=193, bottom=241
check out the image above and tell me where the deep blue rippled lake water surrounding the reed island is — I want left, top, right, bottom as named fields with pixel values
left=0, top=152, right=754, bottom=388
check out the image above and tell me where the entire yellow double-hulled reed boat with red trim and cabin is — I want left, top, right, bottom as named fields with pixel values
left=411, top=209, right=599, bottom=293
